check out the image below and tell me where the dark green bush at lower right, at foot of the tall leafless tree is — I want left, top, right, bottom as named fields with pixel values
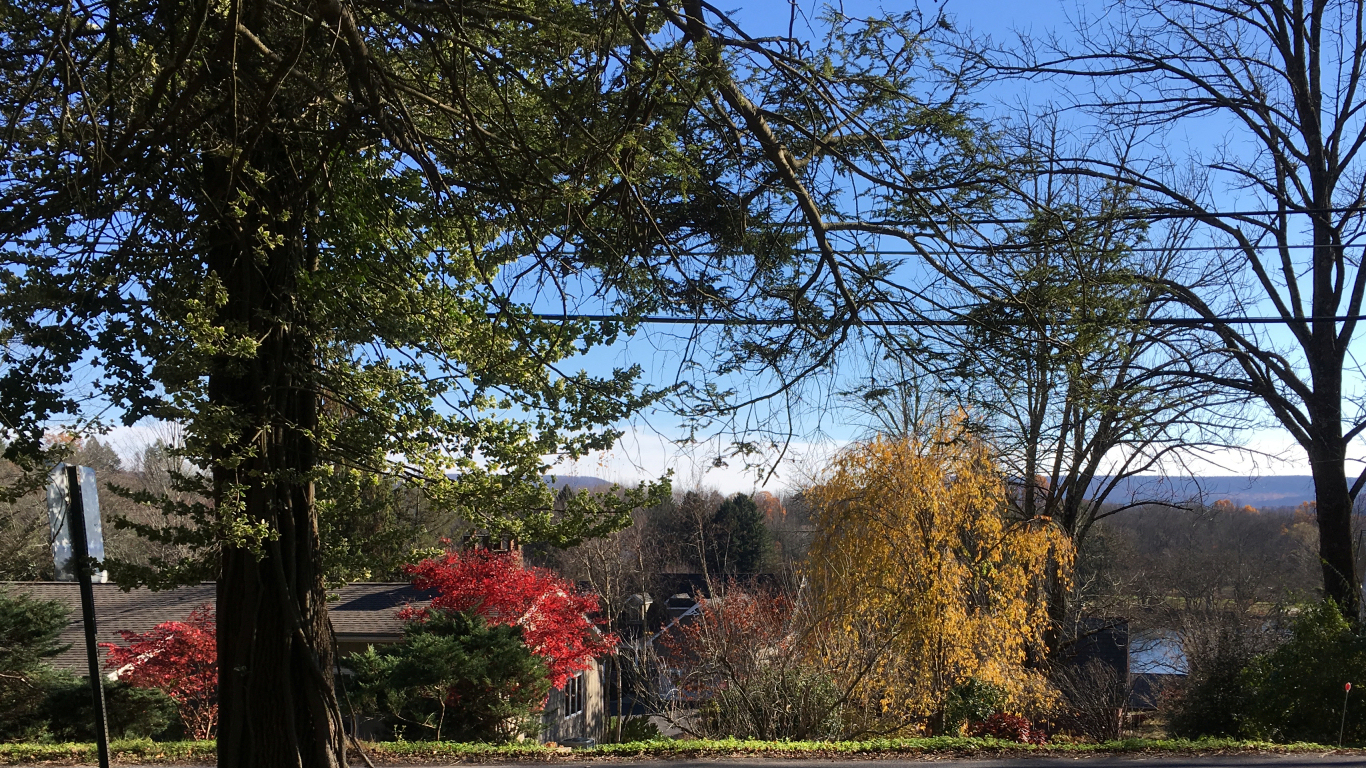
left=1229, top=600, right=1366, bottom=743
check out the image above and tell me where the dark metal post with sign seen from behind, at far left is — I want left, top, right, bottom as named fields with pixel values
left=48, top=465, right=109, bottom=768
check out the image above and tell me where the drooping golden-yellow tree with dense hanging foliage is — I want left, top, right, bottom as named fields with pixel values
left=809, top=417, right=1071, bottom=732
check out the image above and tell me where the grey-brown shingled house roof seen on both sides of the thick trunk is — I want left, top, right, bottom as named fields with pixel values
left=0, top=581, right=434, bottom=674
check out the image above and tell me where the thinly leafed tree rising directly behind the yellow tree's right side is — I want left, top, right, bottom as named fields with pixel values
left=856, top=120, right=1242, bottom=657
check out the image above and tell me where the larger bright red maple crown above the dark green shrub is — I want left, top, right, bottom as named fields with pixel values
left=399, top=549, right=616, bottom=689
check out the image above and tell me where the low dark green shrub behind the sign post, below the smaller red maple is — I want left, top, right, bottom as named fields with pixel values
left=45, top=678, right=180, bottom=741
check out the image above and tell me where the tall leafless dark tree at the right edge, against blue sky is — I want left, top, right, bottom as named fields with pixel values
left=1003, top=0, right=1366, bottom=615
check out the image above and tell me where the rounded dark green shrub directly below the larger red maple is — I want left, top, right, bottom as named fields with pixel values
left=347, top=611, right=549, bottom=742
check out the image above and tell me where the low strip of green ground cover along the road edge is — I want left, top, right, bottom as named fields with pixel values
left=0, top=737, right=1366, bottom=765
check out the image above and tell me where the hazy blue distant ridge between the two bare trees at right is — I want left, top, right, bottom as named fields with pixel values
left=1091, top=474, right=1314, bottom=507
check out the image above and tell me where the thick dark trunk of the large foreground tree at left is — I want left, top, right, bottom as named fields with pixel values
left=205, top=152, right=346, bottom=768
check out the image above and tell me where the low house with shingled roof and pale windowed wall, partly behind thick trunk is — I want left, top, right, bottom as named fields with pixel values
left=0, top=581, right=607, bottom=742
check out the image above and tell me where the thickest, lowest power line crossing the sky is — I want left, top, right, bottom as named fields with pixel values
left=499, top=312, right=1366, bottom=328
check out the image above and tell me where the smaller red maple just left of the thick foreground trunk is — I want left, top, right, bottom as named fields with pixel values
left=100, top=604, right=219, bottom=739
